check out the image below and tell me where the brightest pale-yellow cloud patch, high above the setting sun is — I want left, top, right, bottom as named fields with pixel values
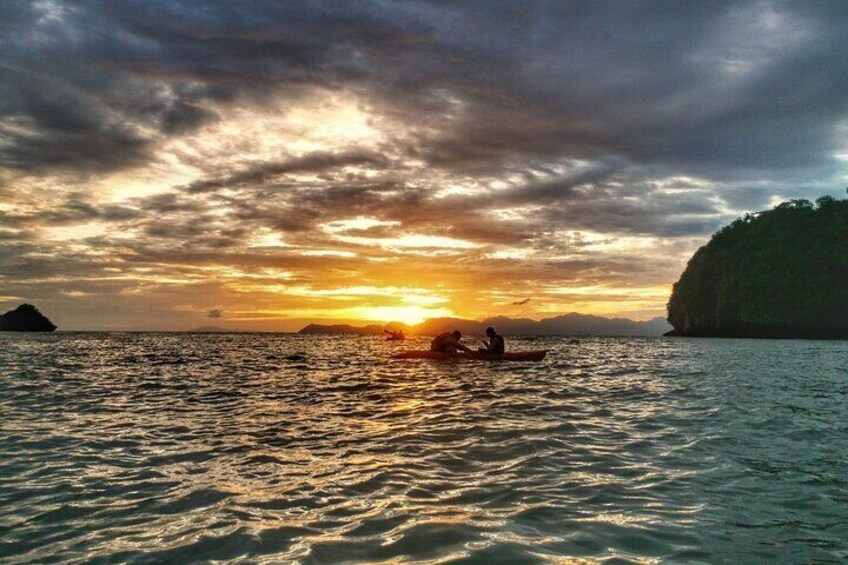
left=99, top=89, right=390, bottom=202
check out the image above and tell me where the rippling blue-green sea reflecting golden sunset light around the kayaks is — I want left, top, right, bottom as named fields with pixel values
left=0, top=333, right=848, bottom=564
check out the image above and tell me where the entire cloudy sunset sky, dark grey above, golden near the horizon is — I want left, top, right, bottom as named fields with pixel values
left=0, top=0, right=848, bottom=331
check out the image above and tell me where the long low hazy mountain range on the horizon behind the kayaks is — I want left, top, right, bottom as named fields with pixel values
left=298, top=313, right=671, bottom=336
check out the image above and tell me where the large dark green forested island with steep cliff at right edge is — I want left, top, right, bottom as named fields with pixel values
left=668, top=197, right=848, bottom=339
